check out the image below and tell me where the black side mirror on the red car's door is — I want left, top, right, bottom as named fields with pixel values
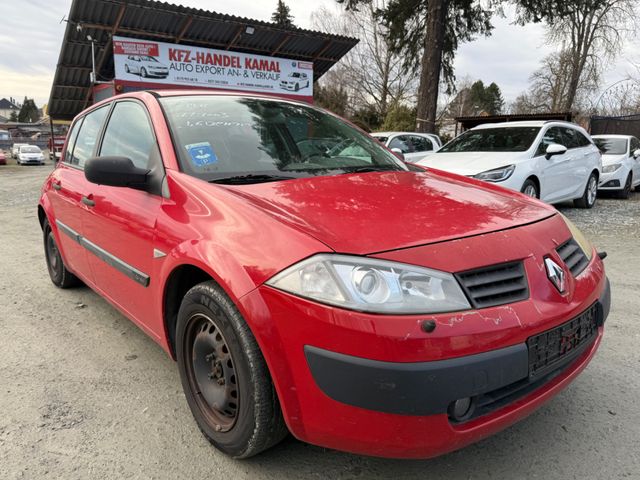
left=84, top=157, right=150, bottom=191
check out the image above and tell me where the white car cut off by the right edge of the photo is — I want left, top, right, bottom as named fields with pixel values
left=591, top=135, right=640, bottom=199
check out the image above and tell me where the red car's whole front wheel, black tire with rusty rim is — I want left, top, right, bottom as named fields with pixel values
left=176, top=281, right=288, bottom=458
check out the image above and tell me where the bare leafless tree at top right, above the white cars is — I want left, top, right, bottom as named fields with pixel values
left=547, top=0, right=637, bottom=111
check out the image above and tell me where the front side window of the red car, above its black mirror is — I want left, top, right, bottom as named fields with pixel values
left=100, top=102, right=155, bottom=168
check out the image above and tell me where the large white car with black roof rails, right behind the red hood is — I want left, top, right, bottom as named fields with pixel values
left=418, top=121, right=602, bottom=208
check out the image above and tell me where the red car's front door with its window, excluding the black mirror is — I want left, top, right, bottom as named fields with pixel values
left=84, top=99, right=164, bottom=333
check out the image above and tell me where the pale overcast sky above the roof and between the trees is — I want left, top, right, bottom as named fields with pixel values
left=0, top=0, right=640, bottom=106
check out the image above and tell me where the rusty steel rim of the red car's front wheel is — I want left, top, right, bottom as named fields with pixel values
left=184, top=313, right=240, bottom=432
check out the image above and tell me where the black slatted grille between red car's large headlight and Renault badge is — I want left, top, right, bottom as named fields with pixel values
left=456, top=262, right=529, bottom=308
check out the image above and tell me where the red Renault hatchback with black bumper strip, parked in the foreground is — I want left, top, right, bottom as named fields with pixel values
left=38, top=91, right=610, bottom=458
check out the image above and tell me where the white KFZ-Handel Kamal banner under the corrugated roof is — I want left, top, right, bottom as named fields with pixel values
left=113, top=37, right=313, bottom=97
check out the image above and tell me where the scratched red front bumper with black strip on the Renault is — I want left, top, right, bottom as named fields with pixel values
left=239, top=216, right=610, bottom=458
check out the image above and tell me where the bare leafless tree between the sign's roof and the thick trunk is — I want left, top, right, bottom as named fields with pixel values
left=312, top=0, right=417, bottom=119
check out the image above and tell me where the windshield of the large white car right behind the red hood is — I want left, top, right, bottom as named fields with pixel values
left=439, top=127, right=540, bottom=152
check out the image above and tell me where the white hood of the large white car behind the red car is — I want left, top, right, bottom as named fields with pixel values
left=417, top=152, right=526, bottom=176
